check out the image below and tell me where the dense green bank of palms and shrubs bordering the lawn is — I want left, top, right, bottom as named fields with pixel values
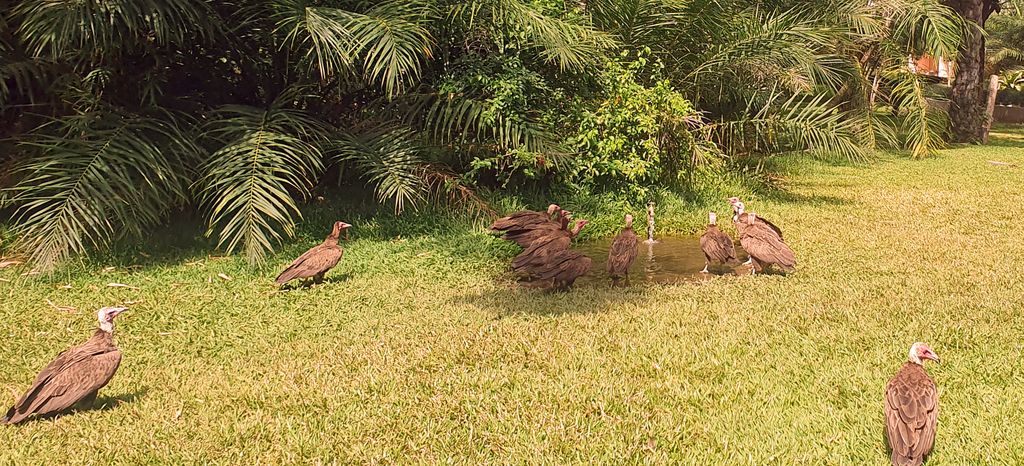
left=0, top=0, right=962, bottom=266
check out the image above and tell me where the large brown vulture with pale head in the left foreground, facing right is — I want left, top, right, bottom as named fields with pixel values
left=0, top=307, right=127, bottom=424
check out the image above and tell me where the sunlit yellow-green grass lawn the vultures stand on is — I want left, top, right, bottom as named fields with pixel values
left=0, top=131, right=1024, bottom=465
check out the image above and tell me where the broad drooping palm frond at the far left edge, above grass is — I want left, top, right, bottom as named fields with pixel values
left=10, top=112, right=199, bottom=270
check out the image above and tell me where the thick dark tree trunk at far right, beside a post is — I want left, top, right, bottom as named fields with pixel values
left=949, top=0, right=985, bottom=142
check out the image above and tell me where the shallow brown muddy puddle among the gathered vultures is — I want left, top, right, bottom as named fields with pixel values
left=573, top=236, right=750, bottom=285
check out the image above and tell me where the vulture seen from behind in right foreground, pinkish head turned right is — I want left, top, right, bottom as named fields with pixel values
left=886, top=342, right=939, bottom=466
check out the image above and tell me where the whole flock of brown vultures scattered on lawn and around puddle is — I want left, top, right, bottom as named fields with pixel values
left=0, top=198, right=939, bottom=466
